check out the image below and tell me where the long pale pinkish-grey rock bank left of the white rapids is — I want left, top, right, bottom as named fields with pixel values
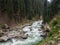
left=0, top=30, right=27, bottom=41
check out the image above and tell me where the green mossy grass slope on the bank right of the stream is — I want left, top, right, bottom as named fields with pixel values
left=36, top=14, right=60, bottom=45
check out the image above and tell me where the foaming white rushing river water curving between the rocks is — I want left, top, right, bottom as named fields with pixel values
left=0, top=20, right=43, bottom=45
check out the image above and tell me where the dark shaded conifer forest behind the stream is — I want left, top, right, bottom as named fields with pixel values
left=0, top=0, right=60, bottom=23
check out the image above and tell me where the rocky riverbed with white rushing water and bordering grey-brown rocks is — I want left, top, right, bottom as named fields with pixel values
left=0, top=20, right=48, bottom=45
